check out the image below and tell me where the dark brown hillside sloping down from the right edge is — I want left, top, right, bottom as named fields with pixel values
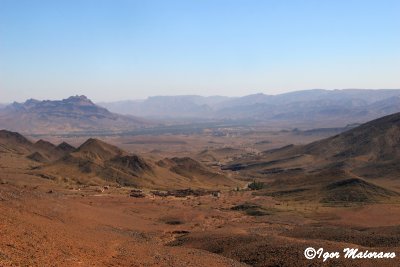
left=223, top=113, right=400, bottom=201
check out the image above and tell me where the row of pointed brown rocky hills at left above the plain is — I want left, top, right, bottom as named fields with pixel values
left=0, top=130, right=241, bottom=190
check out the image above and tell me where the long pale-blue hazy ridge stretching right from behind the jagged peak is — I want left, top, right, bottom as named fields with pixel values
left=99, top=89, right=400, bottom=123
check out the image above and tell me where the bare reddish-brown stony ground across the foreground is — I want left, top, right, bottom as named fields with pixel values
left=0, top=176, right=400, bottom=266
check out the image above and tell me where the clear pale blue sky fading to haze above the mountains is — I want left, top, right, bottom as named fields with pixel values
left=0, top=0, right=400, bottom=102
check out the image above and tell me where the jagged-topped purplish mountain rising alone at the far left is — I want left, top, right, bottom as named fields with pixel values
left=0, top=96, right=149, bottom=134
